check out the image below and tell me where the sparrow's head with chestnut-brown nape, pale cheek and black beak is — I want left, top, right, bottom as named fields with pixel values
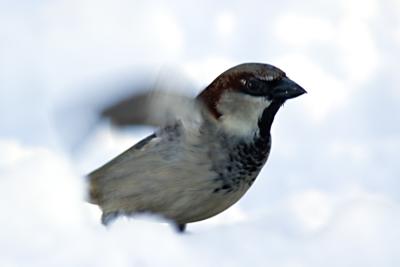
left=198, top=63, right=306, bottom=136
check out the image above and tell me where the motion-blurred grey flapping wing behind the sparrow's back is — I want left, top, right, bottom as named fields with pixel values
left=51, top=67, right=194, bottom=153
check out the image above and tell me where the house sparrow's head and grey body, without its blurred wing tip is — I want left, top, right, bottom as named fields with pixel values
left=88, top=63, right=306, bottom=232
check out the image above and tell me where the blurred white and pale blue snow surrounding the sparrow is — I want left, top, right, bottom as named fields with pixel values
left=0, top=0, right=400, bottom=267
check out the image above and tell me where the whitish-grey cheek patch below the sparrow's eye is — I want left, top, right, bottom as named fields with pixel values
left=217, top=92, right=271, bottom=136
